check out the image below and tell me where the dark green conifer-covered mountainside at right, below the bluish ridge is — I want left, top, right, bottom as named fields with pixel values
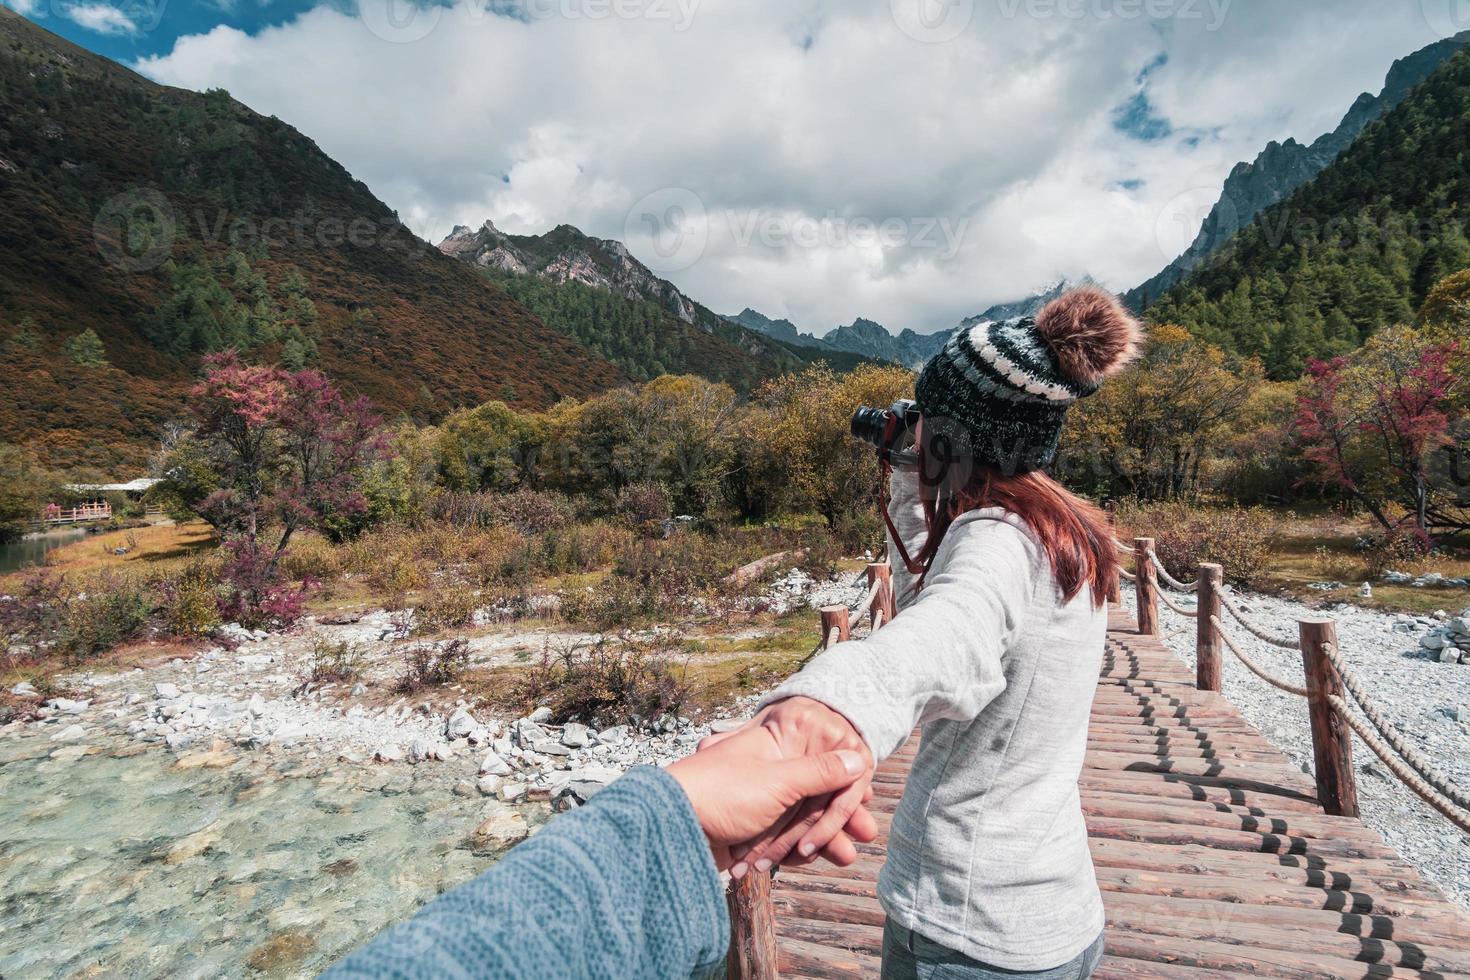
left=1150, top=50, right=1470, bottom=378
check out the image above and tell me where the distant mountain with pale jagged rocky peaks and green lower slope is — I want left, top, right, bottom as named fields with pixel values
left=440, top=222, right=819, bottom=391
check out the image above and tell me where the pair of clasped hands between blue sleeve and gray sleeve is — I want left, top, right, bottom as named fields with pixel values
left=669, top=698, right=878, bottom=879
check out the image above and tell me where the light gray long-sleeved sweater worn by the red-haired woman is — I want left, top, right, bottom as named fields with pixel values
left=766, top=473, right=1107, bottom=970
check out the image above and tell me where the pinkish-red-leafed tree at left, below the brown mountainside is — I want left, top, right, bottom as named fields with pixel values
left=166, top=353, right=390, bottom=621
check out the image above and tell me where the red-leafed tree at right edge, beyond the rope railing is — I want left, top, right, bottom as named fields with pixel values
left=1297, top=328, right=1470, bottom=548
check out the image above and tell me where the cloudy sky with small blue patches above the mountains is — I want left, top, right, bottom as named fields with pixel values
left=11, top=0, right=1470, bottom=332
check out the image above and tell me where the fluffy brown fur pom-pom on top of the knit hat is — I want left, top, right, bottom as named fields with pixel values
left=1036, top=287, right=1144, bottom=385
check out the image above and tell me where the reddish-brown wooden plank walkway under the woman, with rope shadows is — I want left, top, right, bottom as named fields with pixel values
left=772, top=611, right=1470, bottom=980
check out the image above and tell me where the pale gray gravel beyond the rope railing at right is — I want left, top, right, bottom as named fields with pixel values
left=1123, top=588, right=1470, bottom=908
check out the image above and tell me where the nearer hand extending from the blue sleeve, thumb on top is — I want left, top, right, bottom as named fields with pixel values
left=667, top=726, right=876, bottom=870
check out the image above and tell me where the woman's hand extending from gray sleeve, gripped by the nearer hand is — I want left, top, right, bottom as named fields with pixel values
left=698, top=698, right=878, bottom=877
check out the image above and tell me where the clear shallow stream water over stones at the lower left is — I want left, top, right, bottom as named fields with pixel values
left=0, top=729, right=539, bottom=979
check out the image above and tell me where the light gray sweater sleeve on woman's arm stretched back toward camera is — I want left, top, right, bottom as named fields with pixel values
left=761, top=517, right=1044, bottom=761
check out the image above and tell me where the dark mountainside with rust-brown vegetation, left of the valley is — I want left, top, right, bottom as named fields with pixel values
left=0, top=7, right=626, bottom=476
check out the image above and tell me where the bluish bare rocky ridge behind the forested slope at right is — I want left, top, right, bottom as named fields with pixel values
left=1123, top=31, right=1470, bottom=310
